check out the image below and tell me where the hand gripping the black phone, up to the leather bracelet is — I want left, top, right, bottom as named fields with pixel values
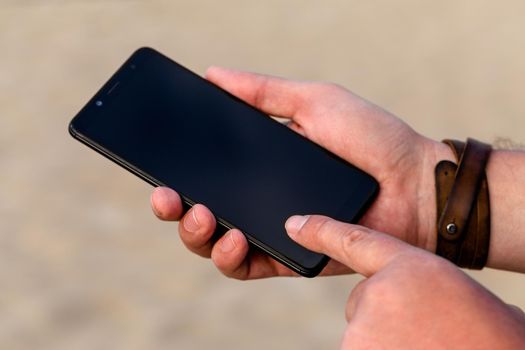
left=147, top=62, right=446, bottom=279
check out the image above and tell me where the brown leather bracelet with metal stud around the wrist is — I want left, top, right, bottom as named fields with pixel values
left=435, top=138, right=492, bottom=269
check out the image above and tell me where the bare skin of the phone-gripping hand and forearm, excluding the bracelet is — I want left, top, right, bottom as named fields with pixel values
left=151, top=67, right=525, bottom=279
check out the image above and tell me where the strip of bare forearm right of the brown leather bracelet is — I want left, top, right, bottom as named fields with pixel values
left=487, top=150, right=525, bottom=272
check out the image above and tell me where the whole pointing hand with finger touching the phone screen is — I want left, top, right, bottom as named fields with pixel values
left=286, top=216, right=525, bottom=350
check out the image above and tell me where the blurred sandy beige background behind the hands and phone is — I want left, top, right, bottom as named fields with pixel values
left=0, top=0, right=525, bottom=350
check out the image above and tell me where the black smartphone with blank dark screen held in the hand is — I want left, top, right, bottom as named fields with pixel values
left=69, top=48, right=378, bottom=277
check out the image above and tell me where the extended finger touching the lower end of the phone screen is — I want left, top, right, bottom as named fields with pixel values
left=285, top=215, right=419, bottom=277
